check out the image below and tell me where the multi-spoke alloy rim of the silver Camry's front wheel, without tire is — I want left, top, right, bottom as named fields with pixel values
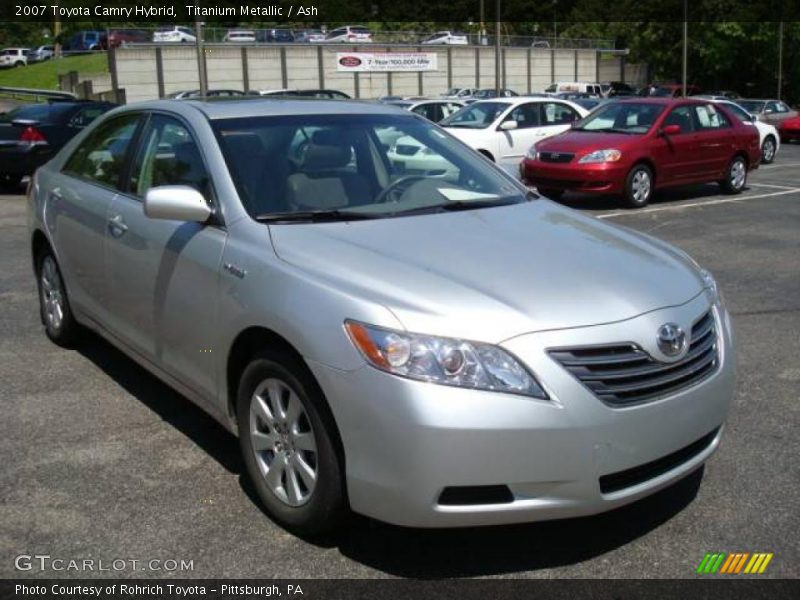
left=249, top=378, right=319, bottom=507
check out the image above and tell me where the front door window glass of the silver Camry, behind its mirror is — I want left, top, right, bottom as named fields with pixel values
left=130, top=115, right=211, bottom=198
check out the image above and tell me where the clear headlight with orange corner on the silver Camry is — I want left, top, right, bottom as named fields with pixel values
left=345, top=321, right=547, bottom=400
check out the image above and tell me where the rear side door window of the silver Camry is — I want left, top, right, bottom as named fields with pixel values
left=64, top=114, right=139, bottom=188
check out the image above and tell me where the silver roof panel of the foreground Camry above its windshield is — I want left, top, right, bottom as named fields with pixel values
left=119, top=96, right=412, bottom=120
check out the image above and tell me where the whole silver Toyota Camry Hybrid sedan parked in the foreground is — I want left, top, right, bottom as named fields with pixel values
left=28, top=99, right=735, bottom=534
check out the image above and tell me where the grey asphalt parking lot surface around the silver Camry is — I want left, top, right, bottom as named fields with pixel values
left=0, top=144, right=800, bottom=578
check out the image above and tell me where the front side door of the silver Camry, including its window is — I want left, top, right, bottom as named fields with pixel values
left=106, top=113, right=227, bottom=396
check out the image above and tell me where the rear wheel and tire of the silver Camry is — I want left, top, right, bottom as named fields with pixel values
left=36, top=248, right=81, bottom=348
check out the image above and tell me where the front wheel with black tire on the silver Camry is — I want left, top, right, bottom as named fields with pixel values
left=236, top=351, right=347, bottom=536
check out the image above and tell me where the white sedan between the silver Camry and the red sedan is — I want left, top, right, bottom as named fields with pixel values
left=439, top=96, right=589, bottom=177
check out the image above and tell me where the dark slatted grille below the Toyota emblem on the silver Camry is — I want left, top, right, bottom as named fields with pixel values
left=550, top=311, right=719, bottom=406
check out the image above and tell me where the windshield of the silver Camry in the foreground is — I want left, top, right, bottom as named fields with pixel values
left=212, top=114, right=529, bottom=222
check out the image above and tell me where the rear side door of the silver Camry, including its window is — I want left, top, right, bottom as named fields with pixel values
left=47, top=113, right=141, bottom=324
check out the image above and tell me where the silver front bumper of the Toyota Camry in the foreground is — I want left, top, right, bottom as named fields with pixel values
left=311, top=294, right=734, bottom=527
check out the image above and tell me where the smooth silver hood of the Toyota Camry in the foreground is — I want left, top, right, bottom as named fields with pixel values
left=270, top=199, right=703, bottom=343
